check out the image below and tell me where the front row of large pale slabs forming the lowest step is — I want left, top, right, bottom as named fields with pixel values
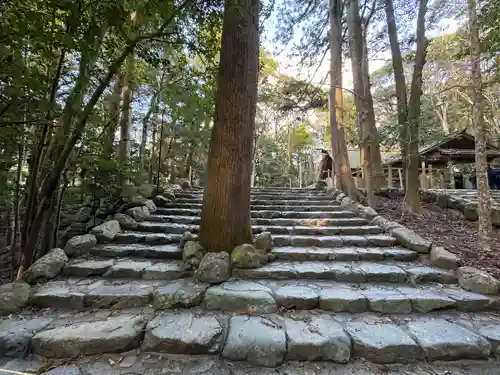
left=8, top=310, right=500, bottom=368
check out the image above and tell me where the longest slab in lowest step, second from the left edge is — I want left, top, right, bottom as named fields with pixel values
left=31, top=315, right=146, bottom=358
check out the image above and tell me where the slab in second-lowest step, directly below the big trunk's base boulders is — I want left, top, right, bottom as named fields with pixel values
left=204, top=281, right=277, bottom=313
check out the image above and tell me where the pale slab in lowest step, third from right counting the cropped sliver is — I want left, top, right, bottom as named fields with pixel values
left=346, top=322, right=421, bottom=363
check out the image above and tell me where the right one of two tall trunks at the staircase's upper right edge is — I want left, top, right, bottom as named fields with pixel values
left=347, top=0, right=376, bottom=207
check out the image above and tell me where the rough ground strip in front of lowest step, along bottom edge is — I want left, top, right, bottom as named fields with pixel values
left=0, top=356, right=498, bottom=375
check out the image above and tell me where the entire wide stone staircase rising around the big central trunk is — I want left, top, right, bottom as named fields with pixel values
left=0, top=188, right=500, bottom=374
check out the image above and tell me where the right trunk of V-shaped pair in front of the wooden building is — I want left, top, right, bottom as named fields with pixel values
left=405, top=0, right=429, bottom=214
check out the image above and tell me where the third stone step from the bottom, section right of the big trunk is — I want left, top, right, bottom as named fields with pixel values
left=233, top=261, right=457, bottom=284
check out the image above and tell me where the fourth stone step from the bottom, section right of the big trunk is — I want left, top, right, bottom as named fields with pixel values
left=272, top=246, right=419, bottom=262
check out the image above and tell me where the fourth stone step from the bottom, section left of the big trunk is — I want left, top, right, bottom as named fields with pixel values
left=90, top=244, right=182, bottom=260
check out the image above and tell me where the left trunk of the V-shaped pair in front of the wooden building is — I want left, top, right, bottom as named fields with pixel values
left=385, top=0, right=408, bottom=186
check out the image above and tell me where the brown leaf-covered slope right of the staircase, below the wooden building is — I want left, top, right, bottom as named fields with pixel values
left=376, top=197, right=500, bottom=279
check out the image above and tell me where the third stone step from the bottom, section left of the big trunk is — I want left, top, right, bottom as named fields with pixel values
left=63, top=258, right=186, bottom=280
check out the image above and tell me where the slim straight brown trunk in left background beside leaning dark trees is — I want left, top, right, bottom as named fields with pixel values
left=117, top=55, right=134, bottom=163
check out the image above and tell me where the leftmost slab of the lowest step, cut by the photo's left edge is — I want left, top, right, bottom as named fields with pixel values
left=0, top=317, right=51, bottom=356
